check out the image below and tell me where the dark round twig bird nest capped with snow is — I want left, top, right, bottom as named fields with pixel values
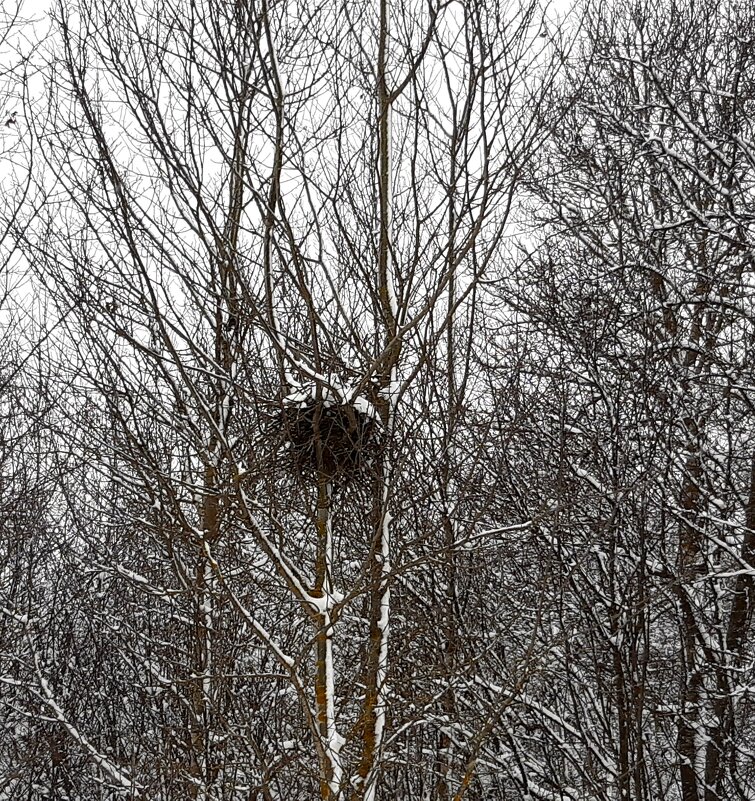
left=279, top=391, right=382, bottom=481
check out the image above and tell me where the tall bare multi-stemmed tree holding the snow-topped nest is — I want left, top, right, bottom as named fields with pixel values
left=2, top=0, right=554, bottom=801
